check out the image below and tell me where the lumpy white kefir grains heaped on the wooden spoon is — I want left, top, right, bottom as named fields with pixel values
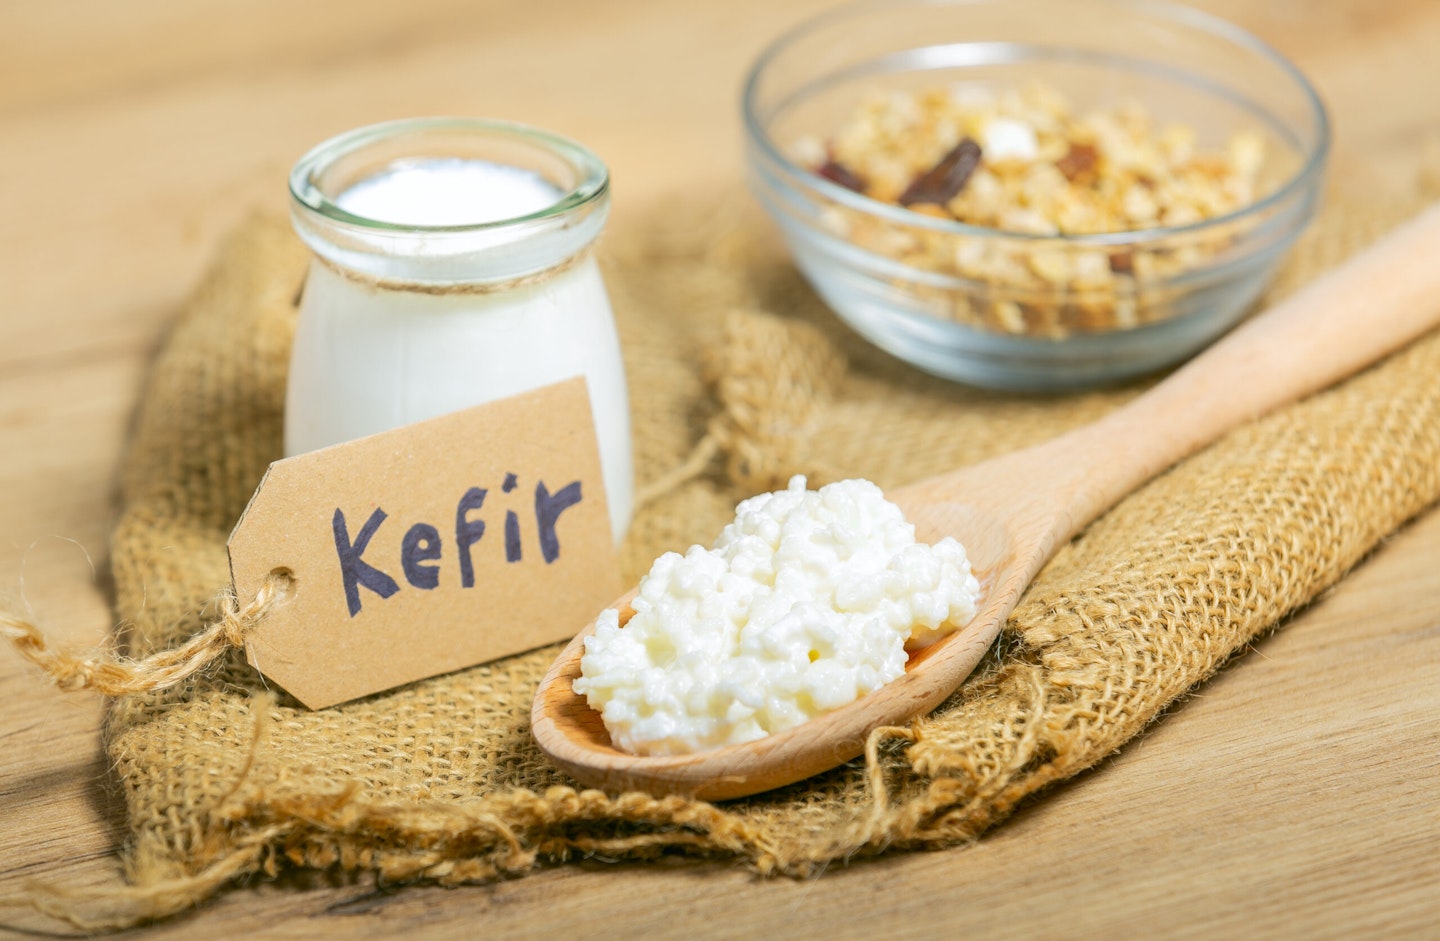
left=575, top=477, right=979, bottom=755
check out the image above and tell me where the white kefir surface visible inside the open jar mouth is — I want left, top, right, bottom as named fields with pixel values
left=336, top=157, right=564, bottom=225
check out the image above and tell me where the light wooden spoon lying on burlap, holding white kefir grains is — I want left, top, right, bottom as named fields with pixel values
left=531, top=206, right=1440, bottom=800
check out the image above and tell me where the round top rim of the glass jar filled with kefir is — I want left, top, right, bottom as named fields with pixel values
left=289, top=117, right=611, bottom=235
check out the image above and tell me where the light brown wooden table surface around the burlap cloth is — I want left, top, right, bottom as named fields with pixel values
left=0, top=0, right=1440, bottom=938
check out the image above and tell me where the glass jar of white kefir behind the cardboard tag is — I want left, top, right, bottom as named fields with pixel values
left=285, top=118, right=634, bottom=542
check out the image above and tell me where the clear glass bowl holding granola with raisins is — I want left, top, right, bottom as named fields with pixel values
left=743, top=0, right=1329, bottom=391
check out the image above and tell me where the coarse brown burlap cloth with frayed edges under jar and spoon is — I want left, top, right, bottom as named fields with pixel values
left=25, top=180, right=1440, bottom=917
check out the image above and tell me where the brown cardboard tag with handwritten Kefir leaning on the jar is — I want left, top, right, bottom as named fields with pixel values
left=229, top=378, right=621, bottom=709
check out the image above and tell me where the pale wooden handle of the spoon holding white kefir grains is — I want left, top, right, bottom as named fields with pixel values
left=1041, top=205, right=1440, bottom=543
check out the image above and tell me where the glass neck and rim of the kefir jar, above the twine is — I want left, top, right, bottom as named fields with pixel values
left=291, top=118, right=609, bottom=291
